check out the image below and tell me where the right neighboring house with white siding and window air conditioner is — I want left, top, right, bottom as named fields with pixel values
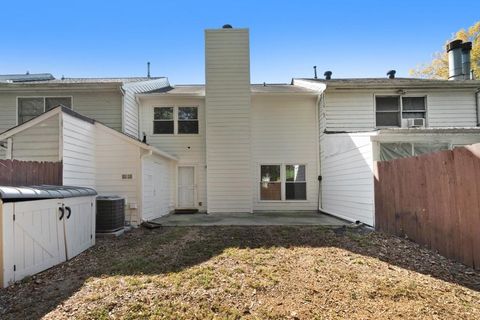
left=293, top=78, right=480, bottom=225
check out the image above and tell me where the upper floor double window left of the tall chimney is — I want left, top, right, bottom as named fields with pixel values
left=153, top=106, right=198, bottom=134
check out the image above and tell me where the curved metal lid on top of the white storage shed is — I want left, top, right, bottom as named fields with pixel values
left=0, top=185, right=97, bottom=201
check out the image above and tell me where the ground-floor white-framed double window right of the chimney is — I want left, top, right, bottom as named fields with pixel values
left=260, top=164, right=307, bottom=201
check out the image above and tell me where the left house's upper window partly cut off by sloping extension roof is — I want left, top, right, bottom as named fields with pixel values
left=18, top=97, right=72, bottom=124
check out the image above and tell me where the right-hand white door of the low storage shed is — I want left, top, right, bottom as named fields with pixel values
left=64, top=197, right=95, bottom=260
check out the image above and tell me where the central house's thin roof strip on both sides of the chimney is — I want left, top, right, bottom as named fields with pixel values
left=139, top=83, right=318, bottom=97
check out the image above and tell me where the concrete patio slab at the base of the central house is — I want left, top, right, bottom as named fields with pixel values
left=148, top=211, right=349, bottom=227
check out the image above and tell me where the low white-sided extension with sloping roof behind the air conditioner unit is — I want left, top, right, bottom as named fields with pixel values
left=0, top=107, right=177, bottom=225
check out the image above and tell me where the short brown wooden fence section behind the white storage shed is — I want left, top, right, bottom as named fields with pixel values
left=0, top=160, right=63, bottom=186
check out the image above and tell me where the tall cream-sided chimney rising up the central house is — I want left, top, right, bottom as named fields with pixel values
left=205, top=29, right=253, bottom=212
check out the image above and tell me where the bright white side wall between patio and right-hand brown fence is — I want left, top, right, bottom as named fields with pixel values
left=321, top=133, right=374, bottom=225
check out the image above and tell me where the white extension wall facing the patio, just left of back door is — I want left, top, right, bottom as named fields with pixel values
left=142, top=155, right=176, bottom=220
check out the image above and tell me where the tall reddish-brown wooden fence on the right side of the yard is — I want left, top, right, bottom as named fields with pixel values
left=375, top=144, right=480, bottom=269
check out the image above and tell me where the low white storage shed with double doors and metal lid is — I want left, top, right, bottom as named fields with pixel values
left=0, top=185, right=97, bottom=287
